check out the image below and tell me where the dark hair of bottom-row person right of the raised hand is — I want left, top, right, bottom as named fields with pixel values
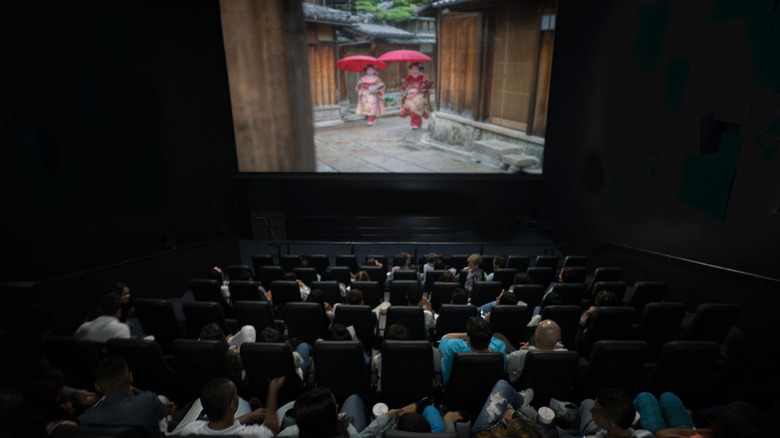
left=293, top=388, right=349, bottom=438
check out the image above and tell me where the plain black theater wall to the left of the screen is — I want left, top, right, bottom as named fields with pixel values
left=0, top=0, right=240, bottom=280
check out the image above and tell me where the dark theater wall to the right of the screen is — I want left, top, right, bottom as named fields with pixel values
left=544, top=0, right=780, bottom=278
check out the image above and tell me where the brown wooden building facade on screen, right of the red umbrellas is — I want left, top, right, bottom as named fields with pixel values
left=434, top=0, right=556, bottom=137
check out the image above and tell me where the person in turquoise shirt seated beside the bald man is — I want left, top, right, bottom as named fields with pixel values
left=439, top=316, right=506, bottom=385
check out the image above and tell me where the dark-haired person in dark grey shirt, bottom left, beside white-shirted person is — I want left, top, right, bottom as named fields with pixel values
left=79, top=357, right=175, bottom=437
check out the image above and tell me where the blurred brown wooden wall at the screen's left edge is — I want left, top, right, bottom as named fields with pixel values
left=220, top=0, right=315, bottom=172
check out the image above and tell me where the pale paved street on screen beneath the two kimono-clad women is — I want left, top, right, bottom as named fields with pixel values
left=314, top=115, right=495, bottom=173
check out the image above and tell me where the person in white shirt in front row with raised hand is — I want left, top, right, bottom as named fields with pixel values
left=174, top=376, right=285, bottom=438
